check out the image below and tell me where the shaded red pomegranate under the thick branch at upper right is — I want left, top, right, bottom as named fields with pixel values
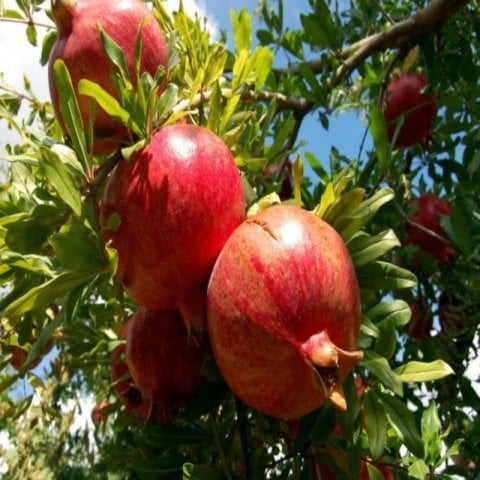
left=384, top=73, right=437, bottom=147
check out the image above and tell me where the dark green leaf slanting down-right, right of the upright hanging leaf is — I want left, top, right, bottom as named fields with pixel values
left=379, top=393, right=423, bottom=458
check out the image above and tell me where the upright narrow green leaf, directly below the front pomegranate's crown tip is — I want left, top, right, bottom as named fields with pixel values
left=363, top=389, right=388, bottom=459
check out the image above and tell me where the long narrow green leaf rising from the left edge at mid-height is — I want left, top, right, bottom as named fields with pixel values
left=4, top=271, right=99, bottom=326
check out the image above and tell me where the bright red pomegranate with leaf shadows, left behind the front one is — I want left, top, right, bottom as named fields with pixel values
left=100, top=125, right=245, bottom=330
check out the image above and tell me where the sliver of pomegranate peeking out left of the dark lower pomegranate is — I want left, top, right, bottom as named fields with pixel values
left=110, top=319, right=152, bottom=418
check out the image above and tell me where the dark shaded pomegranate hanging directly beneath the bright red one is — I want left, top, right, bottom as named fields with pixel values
left=127, top=308, right=205, bottom=421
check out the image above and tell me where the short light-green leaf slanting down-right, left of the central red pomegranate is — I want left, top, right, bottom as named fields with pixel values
left=40, top=148, right=82, bottom=217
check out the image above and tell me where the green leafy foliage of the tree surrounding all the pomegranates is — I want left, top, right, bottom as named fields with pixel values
left=0, top=0, right=480, bottom=480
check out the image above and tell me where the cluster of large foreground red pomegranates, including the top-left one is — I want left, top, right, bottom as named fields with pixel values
left=50, top=0, right=362, bottom=421
